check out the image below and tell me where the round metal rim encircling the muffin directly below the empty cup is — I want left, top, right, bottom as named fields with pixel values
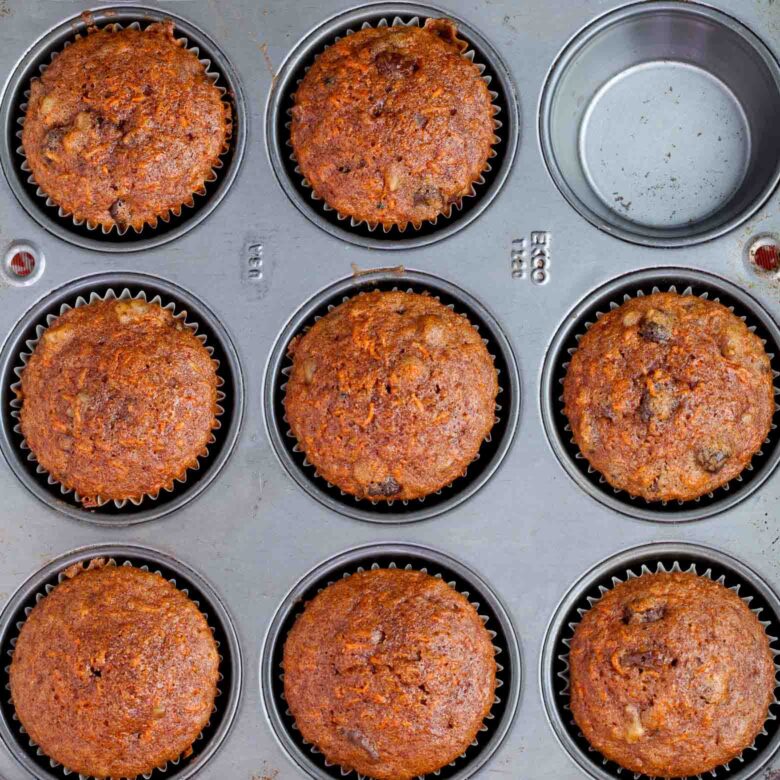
left=539, top=265, right=780, bottom=523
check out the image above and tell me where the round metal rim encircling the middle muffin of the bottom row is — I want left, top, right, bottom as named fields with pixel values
left=259, top=541, right=526, bottom=780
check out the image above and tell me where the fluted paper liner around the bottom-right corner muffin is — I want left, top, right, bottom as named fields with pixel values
left=555, top=559, right=780, bottom=780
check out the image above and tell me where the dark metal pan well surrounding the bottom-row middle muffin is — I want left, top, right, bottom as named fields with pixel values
left=260, top=543, right=521, bottom=780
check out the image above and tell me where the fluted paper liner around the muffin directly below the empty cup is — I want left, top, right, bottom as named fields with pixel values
left=556, top=284, right=780, bottom=507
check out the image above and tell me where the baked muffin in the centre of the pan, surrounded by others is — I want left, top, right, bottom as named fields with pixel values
left=284, top=291, right=498, bottom=501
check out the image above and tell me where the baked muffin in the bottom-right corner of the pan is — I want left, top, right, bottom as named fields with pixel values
left=569, top=573, right=775, bottom=778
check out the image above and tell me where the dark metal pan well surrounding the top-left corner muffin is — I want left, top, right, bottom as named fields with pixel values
left=0, top=5, right=246, bottom=252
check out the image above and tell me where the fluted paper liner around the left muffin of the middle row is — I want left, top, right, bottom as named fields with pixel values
left=10, top=287, right=225, bottom=509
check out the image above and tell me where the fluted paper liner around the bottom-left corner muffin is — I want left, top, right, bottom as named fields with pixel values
left=4, top=557, right=225, bottom=780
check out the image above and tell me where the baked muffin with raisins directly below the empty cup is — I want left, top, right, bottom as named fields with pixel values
left=563, top=293, right=774, bottom=501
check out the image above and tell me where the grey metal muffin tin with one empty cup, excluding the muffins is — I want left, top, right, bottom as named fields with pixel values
left=0, top=0, right=780, bottom=780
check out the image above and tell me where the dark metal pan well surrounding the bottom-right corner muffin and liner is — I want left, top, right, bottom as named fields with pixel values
left=540, top=542, right=780, bottom=780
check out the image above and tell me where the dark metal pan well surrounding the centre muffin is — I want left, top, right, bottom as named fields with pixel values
left=263, top=270, right=520, bottom=523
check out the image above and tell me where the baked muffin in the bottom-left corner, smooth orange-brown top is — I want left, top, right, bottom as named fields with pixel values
left=10, top=560, right=219, bottom=778
